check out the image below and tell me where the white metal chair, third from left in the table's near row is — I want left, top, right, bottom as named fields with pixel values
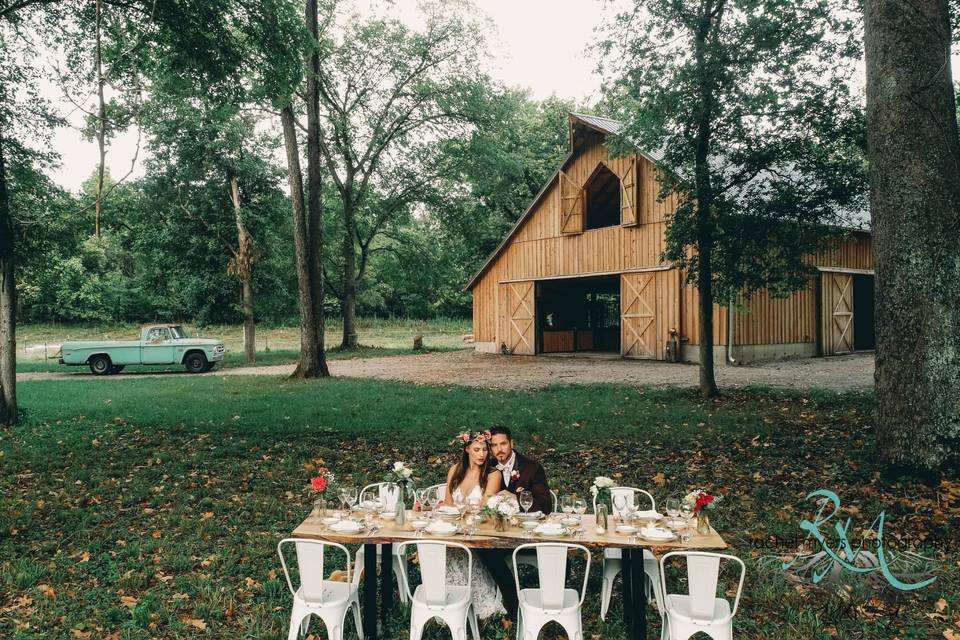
left=513, top=542, right=590, bottom=640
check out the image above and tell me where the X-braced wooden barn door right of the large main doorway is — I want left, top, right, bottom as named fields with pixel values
left=620, top=272, right=658, bottom=358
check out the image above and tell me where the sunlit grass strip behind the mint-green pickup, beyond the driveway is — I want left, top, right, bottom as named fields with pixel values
left=17, top=318, right=471, bottom=373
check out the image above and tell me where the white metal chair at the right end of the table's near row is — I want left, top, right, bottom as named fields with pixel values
left=660, top=551, right=747, bottom=640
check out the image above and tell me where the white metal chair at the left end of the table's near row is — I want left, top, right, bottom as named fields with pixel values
left=277, top=538, right=363, bottom=640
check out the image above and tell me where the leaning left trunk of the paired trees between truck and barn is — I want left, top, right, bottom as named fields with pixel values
left=280, top=105, right=324, bottom=378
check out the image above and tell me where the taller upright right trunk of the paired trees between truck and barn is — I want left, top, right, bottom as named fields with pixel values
left=304, top=0, right=330, bottom=376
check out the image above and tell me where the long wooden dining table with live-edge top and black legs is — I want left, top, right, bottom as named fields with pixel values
left=293, top=512, right=727, bottom=640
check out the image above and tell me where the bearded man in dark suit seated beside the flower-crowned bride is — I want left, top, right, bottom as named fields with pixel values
left=477, top=425, right=553, bottom=620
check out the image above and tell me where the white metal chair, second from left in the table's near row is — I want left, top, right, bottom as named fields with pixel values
left=397, top=540, right=480, bottom=640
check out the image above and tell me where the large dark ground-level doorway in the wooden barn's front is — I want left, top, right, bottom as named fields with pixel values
left=536, top=275, right=620, bottom=353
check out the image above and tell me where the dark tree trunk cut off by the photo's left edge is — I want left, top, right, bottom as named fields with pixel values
left=0, top=128, right=17, bottom=425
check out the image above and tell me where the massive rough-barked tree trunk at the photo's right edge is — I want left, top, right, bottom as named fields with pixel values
left=865, top=0, right=960, bottom=470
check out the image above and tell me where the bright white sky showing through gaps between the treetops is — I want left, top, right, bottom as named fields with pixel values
left=46, top=0, right=604, bottom=191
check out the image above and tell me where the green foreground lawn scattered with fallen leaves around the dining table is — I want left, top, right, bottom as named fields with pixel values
left=0, top=376, right=960, bottom=640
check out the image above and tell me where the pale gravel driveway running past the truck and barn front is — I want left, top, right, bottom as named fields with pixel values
left=17, top=351, right=873, bottom=390
